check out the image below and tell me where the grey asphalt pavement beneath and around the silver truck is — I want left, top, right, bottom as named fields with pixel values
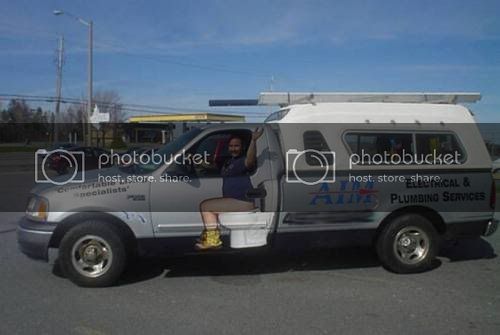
left=0, top=156, right=500, bottom=334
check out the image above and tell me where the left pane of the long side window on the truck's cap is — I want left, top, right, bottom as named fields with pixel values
left=345, top=133, right=413, bottom=155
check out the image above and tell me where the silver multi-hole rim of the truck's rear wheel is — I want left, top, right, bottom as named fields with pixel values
left=394, top=227, right=430, bottom=265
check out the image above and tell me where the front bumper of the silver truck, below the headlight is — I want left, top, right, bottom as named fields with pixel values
left=17, top=216, right=56, bottom=261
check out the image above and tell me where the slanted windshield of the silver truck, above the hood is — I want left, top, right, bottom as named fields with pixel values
left=127, top=128, right=201, bottom=173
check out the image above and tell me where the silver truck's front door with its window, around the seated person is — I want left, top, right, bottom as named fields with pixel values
left=151, top=125, right=277, bottom=237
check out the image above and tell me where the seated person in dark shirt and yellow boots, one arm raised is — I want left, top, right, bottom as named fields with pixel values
left=195, top=128, right=264, bottom=250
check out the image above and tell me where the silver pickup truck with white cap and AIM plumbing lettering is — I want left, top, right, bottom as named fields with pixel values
left=18, top=93, right=498, bottom=287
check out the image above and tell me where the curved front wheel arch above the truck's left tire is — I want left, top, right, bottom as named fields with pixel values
left=49, top=212, right=137, bottom=251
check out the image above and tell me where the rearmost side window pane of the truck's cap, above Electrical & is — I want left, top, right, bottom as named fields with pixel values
left=415, top=133, right=465, bottom=164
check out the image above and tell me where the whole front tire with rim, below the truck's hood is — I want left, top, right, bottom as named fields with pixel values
left=59, top=221, right=127, bottom=287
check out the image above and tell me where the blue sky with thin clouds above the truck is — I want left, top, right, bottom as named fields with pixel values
left=0, top=0, right=500, bottom=122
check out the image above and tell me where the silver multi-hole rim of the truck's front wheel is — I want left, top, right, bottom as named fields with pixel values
left=71, top=235, right=113, bottom=278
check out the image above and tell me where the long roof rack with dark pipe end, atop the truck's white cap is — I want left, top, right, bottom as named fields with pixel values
left=209, top=92, right=481, bottom=107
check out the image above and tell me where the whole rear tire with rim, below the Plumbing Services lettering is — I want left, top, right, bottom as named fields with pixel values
left=375, top=214, right=439, bottom=273
